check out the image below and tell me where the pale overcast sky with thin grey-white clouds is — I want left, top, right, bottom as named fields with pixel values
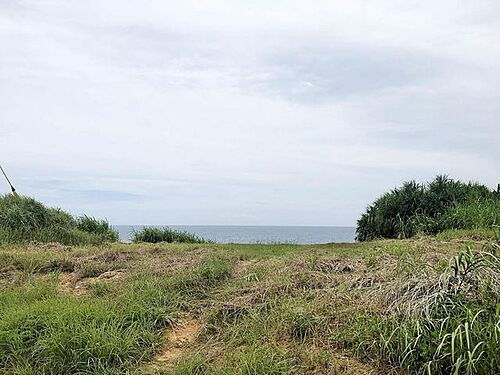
left=0, top=0, right=500, bottom=225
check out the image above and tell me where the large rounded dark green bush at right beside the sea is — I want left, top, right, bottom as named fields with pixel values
left=356, top=176, right=500, bottom=241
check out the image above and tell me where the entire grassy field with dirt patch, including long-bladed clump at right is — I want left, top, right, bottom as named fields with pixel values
left=0, top=234, right=500, bottom=375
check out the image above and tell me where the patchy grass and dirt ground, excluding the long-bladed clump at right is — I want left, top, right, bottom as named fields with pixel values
left=0, top=238, right=498, bottom=375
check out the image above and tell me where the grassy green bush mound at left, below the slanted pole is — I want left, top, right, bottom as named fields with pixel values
left=0, top=194, right=118, bottom=245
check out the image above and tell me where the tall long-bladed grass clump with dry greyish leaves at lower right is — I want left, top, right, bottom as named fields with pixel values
left=358, top=244, right=500, bottom=375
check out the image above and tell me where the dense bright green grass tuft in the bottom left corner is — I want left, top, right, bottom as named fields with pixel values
left=0, top=297, right=158, bottom=374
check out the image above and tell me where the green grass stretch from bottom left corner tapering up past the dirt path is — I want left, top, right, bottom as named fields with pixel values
left=0, top=256, right=231, bottom=374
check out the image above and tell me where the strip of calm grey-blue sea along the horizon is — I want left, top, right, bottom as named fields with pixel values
left=114, top=225, right=356, bottom=244
